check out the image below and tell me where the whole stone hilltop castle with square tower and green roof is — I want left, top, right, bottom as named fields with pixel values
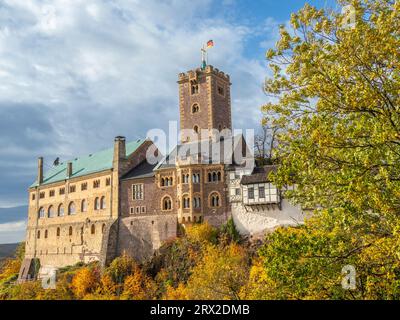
left=19, top=65, right=303, bottom=281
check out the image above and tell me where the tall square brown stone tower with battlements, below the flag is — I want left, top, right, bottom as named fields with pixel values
left=178, top=65, right=232, bottom=143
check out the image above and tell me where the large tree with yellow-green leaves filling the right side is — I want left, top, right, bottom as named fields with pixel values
left=261, top=0, right=400, bottom=299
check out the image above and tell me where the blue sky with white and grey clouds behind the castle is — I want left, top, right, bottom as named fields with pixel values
left=0, top=0, right=337, bottom=242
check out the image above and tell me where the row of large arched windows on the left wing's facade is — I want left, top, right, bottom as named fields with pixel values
left=38, top=196, right=106, bottom=219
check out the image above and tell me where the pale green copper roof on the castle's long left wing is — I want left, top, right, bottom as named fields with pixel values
left=30, top=139, right=145, bottom=188
